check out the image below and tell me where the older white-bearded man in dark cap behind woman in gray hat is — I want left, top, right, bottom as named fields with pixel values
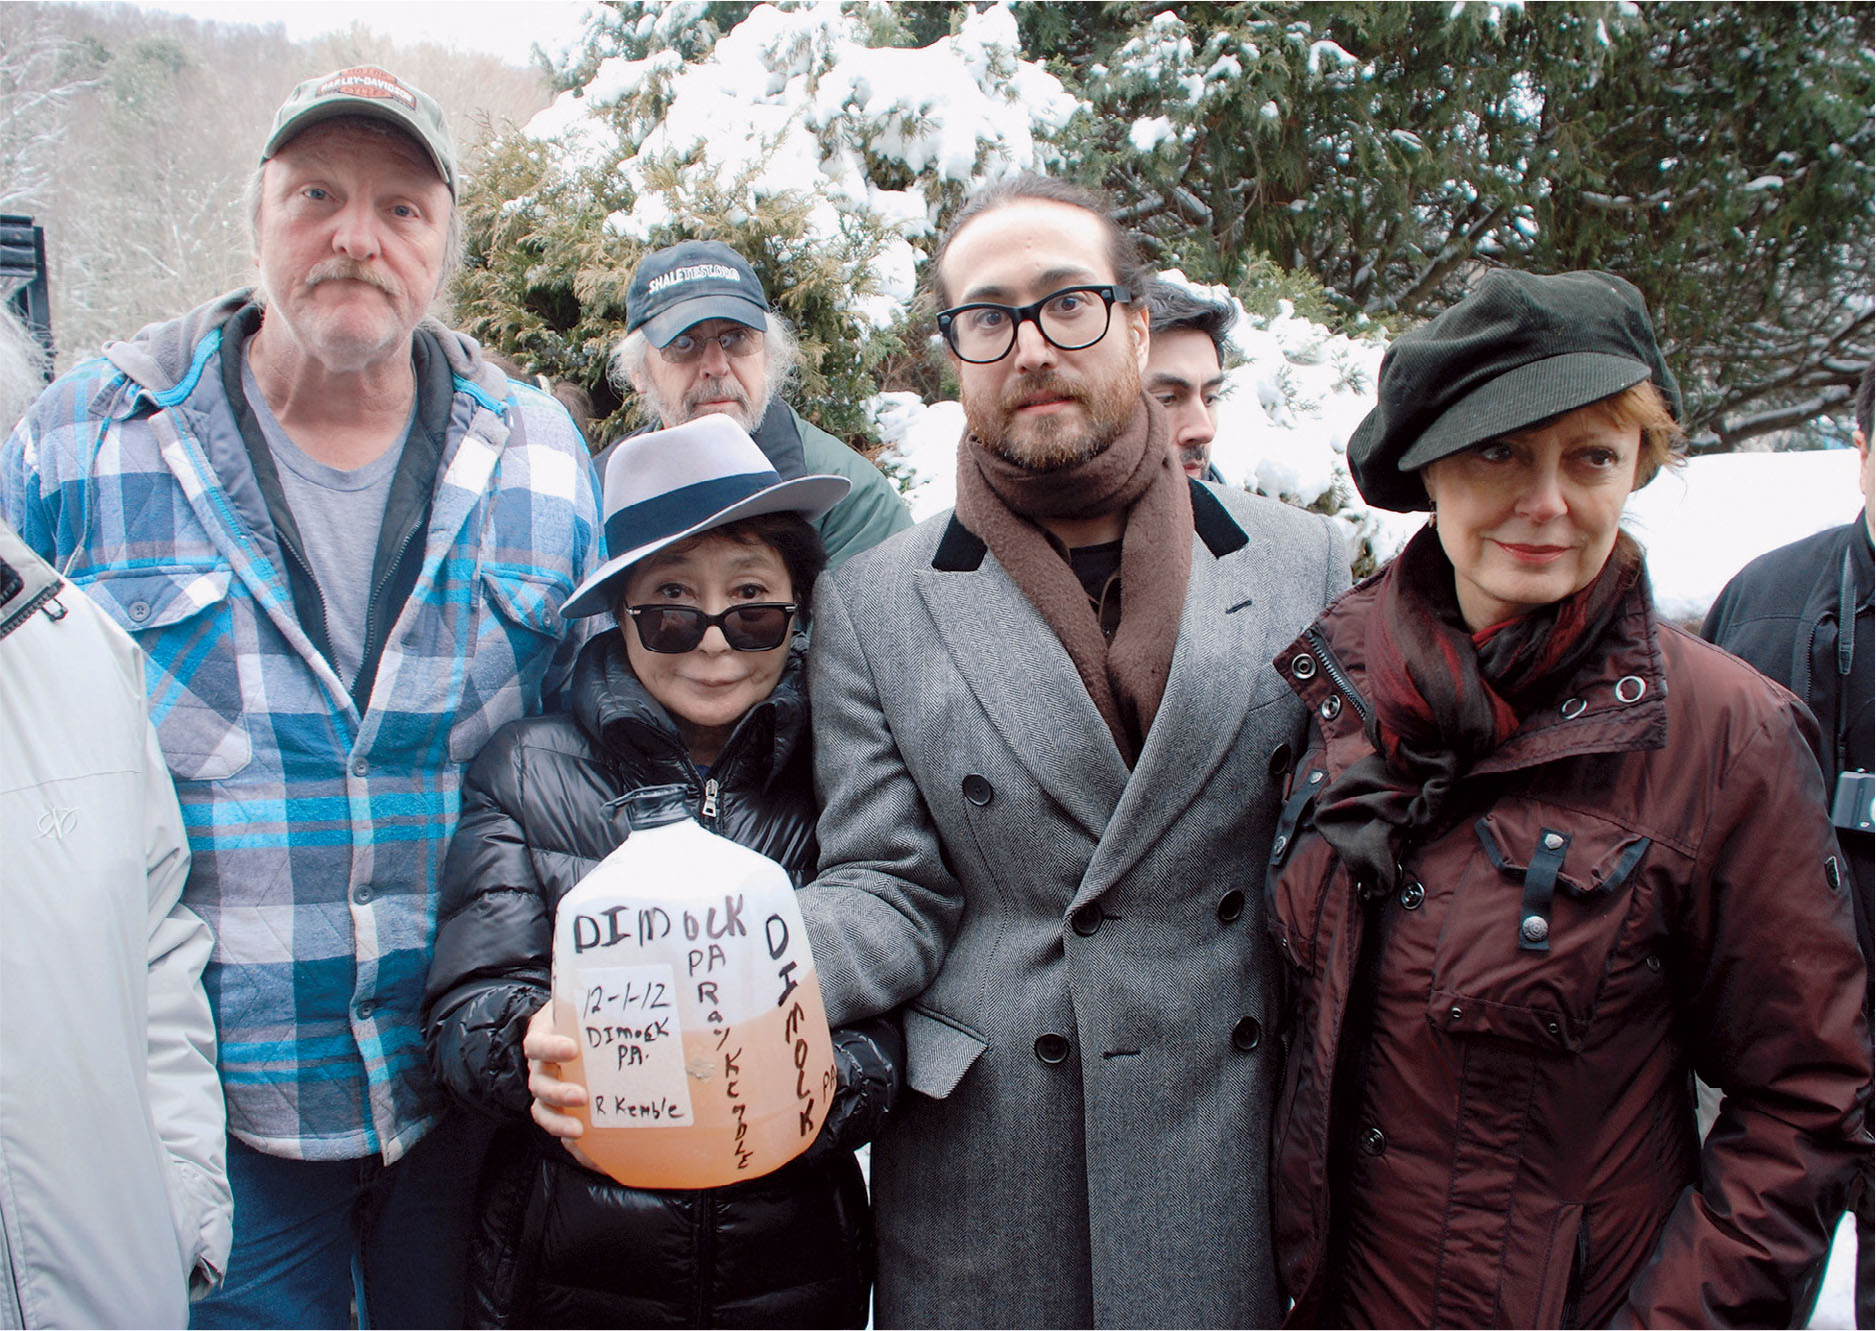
left=600, top=240, right=912, bottom=567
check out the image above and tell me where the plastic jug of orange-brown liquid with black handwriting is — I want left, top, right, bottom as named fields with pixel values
left=553, top=787, right=835, bottom=1188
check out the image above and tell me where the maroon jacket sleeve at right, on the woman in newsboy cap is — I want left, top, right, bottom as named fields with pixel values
left=1617, top=695, right=1870, bottom=1325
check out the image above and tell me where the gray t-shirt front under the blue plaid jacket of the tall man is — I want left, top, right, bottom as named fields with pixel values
left=240, top=352, right=416, bottom=689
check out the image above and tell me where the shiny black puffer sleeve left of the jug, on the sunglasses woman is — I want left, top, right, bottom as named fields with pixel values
left=422, top=723, right=553, bottom=1117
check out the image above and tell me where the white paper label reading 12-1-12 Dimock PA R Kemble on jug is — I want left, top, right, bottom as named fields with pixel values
left=580, top=965, right=690, bottom=1128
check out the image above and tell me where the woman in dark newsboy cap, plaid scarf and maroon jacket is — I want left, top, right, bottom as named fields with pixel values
left=1266, top=270, right=1870, bottom=1327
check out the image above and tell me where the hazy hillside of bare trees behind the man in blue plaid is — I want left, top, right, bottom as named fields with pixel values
left=11, top=4, right=552, bottom=368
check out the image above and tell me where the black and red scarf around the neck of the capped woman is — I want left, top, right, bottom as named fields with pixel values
left=1315, top=528, right=1642, bottom=890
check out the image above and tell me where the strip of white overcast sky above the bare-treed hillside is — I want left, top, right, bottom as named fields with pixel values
left=137, top=0, right=589, bottom=68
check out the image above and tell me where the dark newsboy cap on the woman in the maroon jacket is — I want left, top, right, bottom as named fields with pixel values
left=1349, top=268, right=1681, bottom=513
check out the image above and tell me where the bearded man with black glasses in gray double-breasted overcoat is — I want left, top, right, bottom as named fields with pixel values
left=801, top=176, right=1347, bottom=1327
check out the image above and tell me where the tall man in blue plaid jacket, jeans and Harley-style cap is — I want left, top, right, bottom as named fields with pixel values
left=0, top=68, right=602, bottom=1325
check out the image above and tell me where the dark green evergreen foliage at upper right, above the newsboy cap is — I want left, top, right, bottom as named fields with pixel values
left=1065, top=2, right=1876, bottom=443
